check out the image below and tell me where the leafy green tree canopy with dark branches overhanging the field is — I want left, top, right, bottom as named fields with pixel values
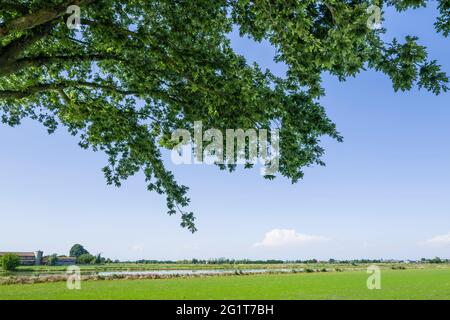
left=0, top=0, right=450, bottom=232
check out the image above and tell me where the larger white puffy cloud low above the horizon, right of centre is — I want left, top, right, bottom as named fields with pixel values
left=255, top=229, right=329, bottom=248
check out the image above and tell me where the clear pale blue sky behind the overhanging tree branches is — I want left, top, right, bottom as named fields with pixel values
left=0, top=4, right=450, bottom=259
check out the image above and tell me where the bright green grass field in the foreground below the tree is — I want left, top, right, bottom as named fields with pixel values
left=0, top=269, right=450, bottom=300
